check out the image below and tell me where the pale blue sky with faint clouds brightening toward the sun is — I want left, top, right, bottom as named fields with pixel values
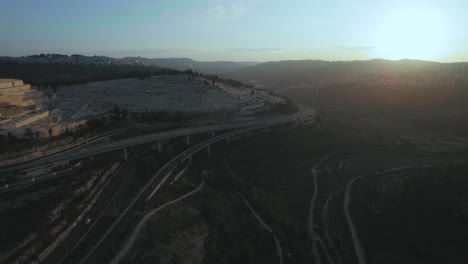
left=0, top=0, right=468, bottom=62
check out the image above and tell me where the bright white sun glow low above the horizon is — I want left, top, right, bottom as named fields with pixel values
left=374, top=8, right=450, bottom=60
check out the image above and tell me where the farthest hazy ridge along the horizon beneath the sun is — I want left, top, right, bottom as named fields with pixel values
left=230, top=60, right=468, bottom=90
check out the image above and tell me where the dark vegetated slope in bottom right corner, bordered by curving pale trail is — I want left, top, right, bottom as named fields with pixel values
left=351, top=164, right=468, bottom=263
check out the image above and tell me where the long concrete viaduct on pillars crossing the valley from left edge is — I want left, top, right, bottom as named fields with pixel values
left=0, top=113, right=315, bottom=193
